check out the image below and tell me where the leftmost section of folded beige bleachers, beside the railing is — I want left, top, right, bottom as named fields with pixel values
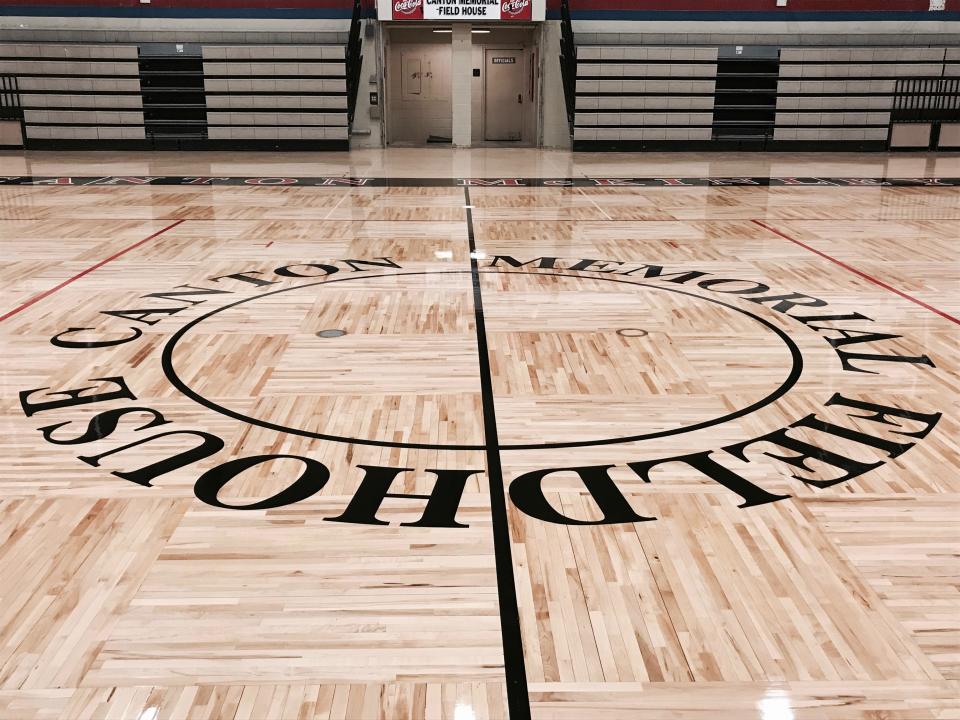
left=0, top=43, right=144, bottom=143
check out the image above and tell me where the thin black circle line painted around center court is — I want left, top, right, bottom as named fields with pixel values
left=160, top=270, right=803, bottom=450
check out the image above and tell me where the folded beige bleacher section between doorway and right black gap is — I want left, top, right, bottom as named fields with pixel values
left=573, top=45, right=717, bottom=142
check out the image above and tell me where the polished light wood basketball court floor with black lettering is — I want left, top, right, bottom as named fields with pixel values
left=0, top=151, right=960, bottom=720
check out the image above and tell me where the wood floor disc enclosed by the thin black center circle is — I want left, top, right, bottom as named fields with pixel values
left=162, top=270, right=803, bottom=450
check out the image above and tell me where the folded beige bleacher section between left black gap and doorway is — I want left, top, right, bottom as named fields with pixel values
left=202, top=45, right=348, bottom=142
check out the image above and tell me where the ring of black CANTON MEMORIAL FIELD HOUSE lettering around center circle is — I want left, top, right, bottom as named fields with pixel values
left=19, top=255, right=941, bottom=528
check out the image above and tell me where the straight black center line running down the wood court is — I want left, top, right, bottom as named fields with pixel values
left=463, top=186, right=530, bottom=720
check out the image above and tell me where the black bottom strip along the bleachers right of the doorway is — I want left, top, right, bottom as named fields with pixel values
left=573, top=140, right=887, bottom=152
